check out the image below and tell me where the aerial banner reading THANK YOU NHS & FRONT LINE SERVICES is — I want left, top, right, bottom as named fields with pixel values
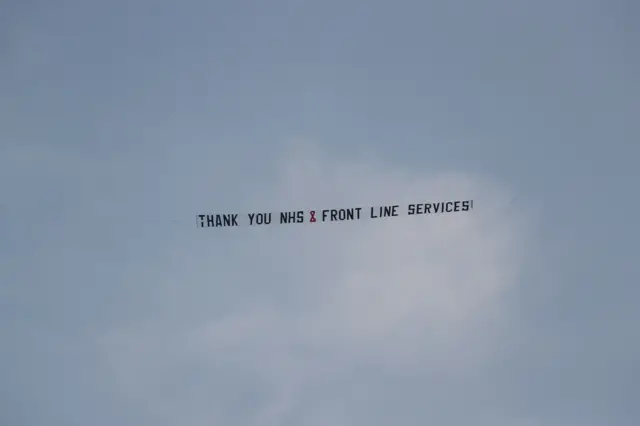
left=196, top=200, right=473, bottom=228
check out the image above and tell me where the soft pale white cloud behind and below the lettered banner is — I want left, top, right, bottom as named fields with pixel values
left=100, top=140, right=531, bottom=425
